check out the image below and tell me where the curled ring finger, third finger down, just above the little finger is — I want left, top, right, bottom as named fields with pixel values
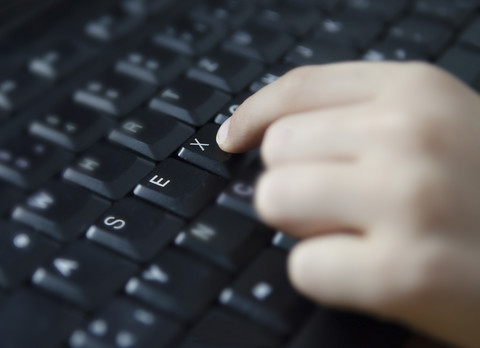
left=255, top=162, right=388, bottom=238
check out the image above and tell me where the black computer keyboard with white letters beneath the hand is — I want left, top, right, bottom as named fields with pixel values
left=0, top=0, right=480, bottom=348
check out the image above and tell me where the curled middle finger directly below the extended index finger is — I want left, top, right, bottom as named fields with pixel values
left=261, top=104, right=385, bottom=166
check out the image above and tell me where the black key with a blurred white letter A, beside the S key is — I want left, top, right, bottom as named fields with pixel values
left=32, top=242, right=136, bottom=309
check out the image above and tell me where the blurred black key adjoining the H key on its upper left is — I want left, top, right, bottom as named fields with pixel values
left=29, top=100, right=114, bottom=152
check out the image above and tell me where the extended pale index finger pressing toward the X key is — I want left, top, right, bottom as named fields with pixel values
left=217, top=62, right=399, bottom=152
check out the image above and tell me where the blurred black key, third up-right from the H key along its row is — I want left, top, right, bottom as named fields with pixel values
left=187, top=51, right=263, bottom=93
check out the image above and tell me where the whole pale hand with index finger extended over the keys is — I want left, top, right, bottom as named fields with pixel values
left=217, top=63, right=480, bottom=347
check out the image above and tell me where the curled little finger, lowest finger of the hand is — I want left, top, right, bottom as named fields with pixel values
left=288, top=234, right=386, bottom=310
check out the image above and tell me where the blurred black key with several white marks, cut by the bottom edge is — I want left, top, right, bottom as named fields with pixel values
left=70, top=298, right=180, bottom=348
